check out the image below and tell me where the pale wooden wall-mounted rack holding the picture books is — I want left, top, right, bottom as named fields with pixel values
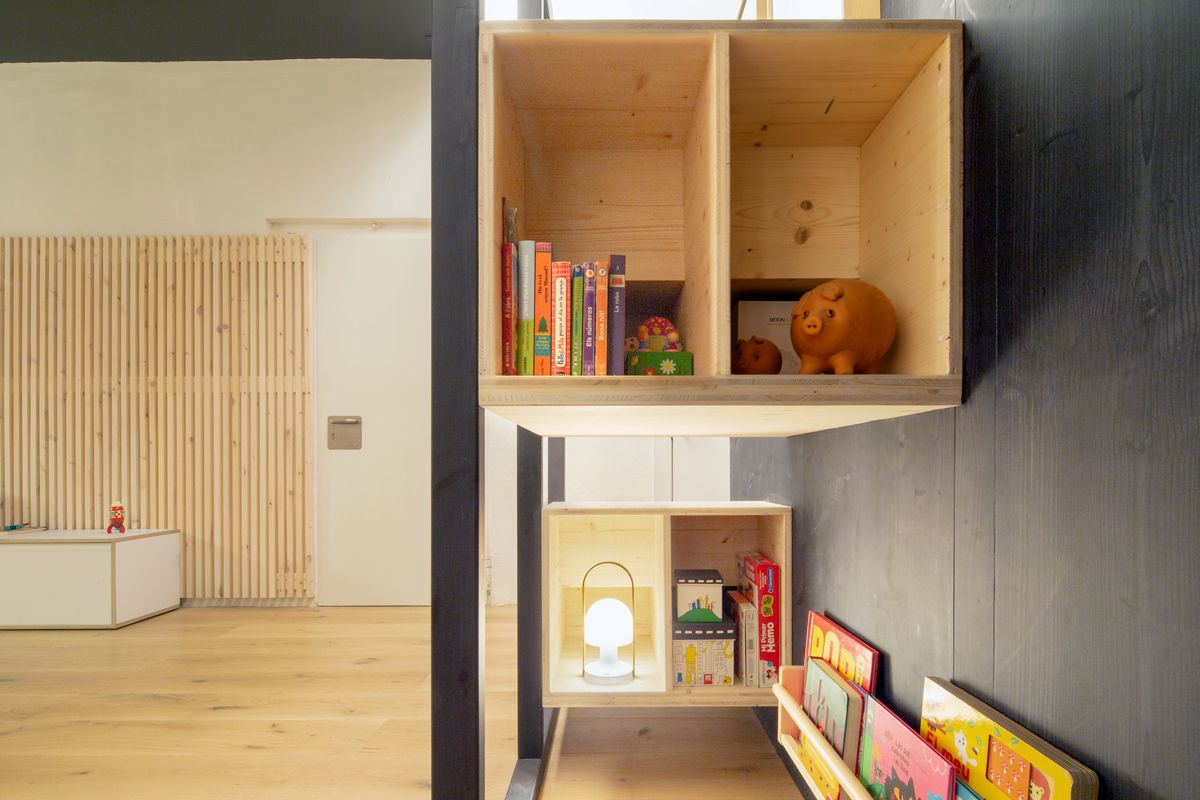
left=774, top=667, right=872, bottom=800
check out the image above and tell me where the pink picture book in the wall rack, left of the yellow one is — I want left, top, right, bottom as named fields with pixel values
left=858, top=697, right=955, bottom=800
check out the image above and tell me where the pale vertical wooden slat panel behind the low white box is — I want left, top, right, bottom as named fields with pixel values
left=0, top=236, right=313, bottom=599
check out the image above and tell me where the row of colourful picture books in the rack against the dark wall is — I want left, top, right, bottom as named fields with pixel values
left=781, top=612, right=1098, bottom=800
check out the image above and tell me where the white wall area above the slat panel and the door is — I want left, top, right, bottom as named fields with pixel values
left=0, top=60, right=431, bottom=235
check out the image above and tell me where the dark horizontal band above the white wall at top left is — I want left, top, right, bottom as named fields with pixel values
left=0, top=0, right=433, bottom=61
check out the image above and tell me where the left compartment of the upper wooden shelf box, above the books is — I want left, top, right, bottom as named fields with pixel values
left=480, top=26, right=728, bottom=375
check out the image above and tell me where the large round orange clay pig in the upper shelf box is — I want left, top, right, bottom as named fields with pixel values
left=792, top=279, right=896, bottom=375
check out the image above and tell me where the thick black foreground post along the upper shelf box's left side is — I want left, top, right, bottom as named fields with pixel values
left=432, top=0, right=484, bottom=800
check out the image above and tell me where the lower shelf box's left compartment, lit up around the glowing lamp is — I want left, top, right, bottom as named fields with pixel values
left=542, top=511, right=670, bottom=705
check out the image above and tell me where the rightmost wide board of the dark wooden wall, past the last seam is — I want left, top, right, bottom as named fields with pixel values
left=973, top=0, right=1200, bottom=796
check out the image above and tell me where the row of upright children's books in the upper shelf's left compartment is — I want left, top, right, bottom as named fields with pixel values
left=500, top=240, right=625, bottom=375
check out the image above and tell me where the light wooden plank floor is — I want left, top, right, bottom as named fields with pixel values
left=0, top=608, right=799, bottom=800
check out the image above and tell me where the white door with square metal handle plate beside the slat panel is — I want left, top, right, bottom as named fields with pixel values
left=312, top=233, right=432, bottom=606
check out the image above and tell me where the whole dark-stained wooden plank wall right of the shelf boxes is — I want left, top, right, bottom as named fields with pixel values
left=733, top=0, right=1200, bottom=798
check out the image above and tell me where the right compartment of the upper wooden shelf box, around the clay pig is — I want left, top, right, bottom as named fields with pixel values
left=730, top=28, right=961, bottom=375
